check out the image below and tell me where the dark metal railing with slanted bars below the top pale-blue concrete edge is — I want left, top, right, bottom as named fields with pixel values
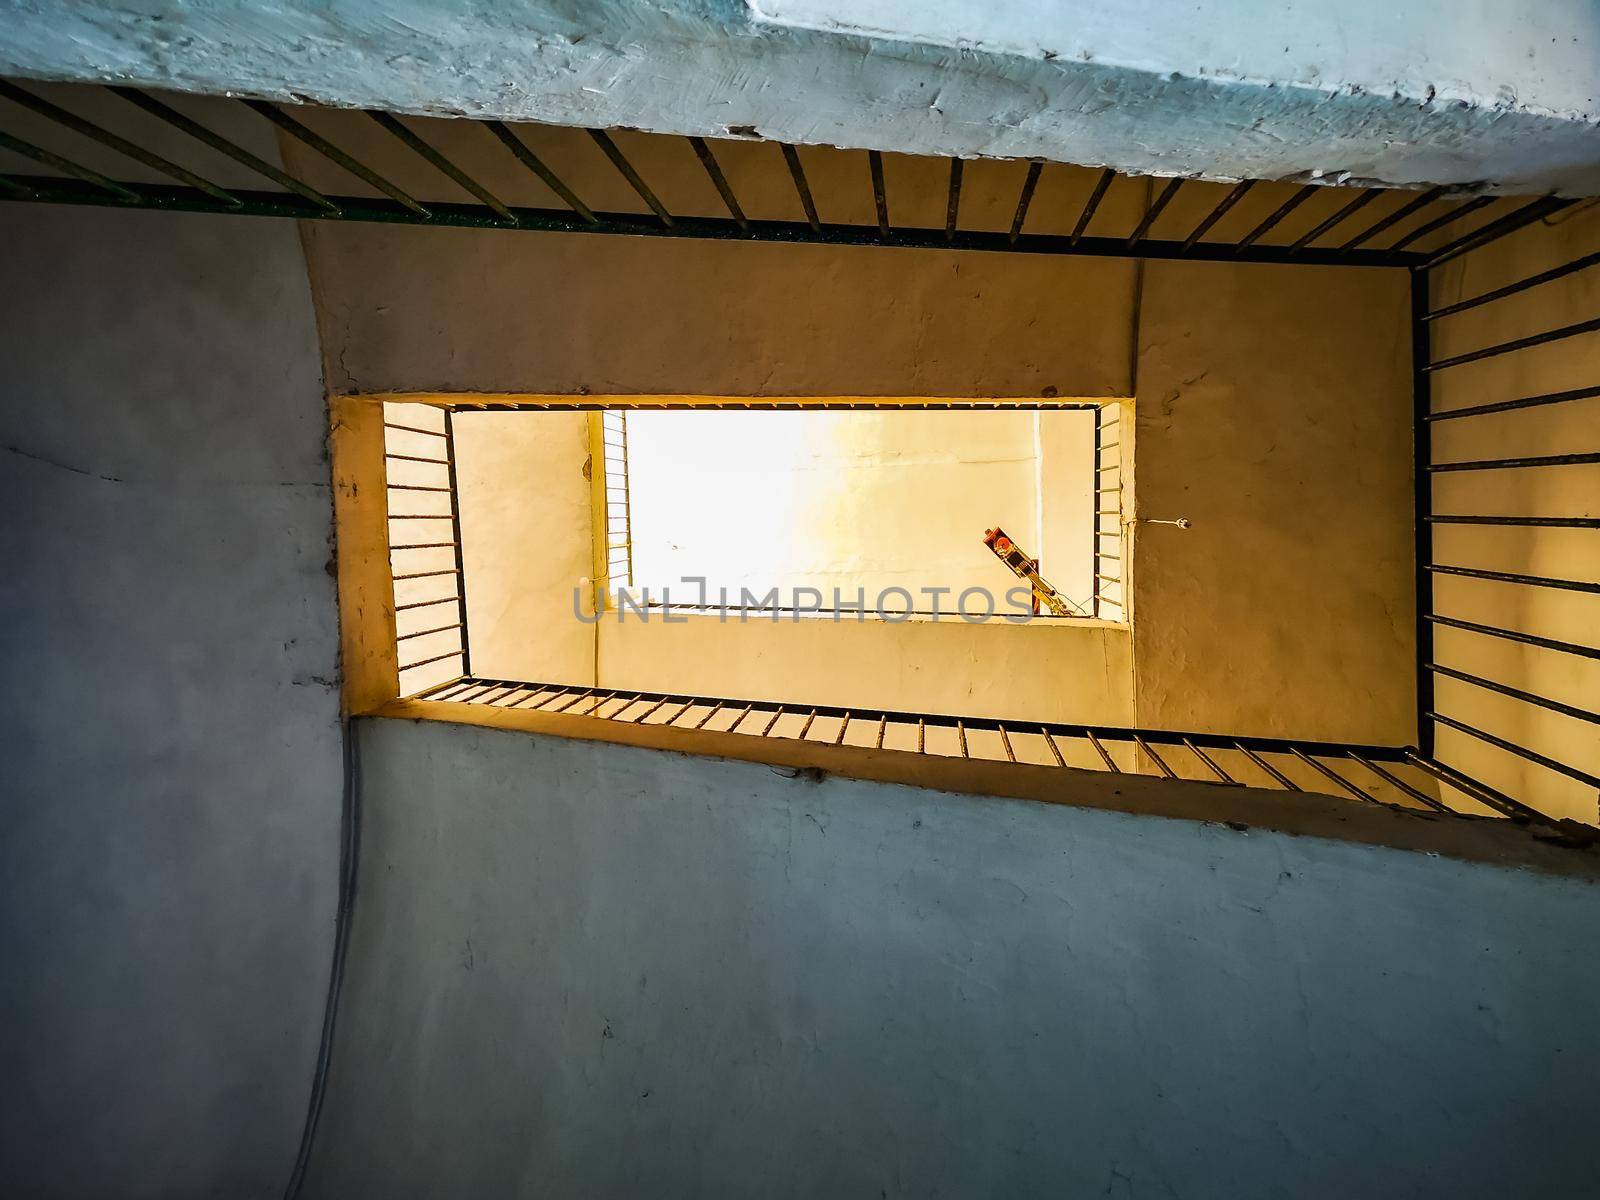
left=0, top=80, right=1571, bottom=267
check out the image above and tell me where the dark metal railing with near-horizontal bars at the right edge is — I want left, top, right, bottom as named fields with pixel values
left=1411, top=200, right=1600, bottom=832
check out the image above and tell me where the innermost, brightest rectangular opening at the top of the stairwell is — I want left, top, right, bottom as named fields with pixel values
left=600, top=403, right=1122, bottom=622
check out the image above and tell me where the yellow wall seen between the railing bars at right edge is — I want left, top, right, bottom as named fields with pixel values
left=1432, top=208, right=1600, bottom=821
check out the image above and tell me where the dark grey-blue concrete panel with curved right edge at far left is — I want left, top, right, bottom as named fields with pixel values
left=0, top=110, right=342, bottom=1198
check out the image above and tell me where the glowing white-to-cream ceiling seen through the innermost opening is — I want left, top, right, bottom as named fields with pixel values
left=627, top=410, right=1093, bottom=613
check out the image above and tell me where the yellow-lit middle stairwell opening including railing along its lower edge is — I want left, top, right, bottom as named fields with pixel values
left=321, top=397, right=1548, bottom=832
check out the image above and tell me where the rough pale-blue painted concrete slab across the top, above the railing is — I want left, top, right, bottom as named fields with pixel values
left=0, top=0, right=1600, bottom=194
